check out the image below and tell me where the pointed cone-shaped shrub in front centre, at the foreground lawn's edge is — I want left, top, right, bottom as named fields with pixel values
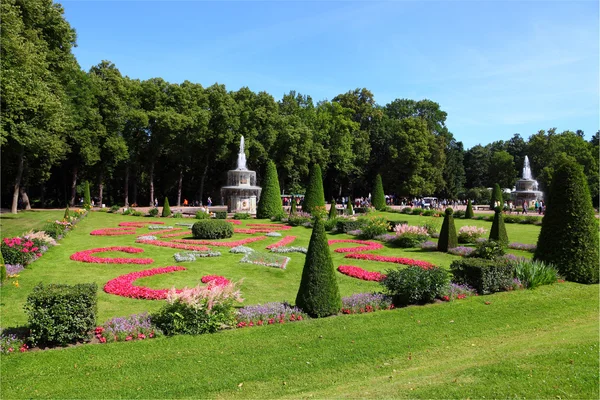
left=296, top=218, right=342, bottom=318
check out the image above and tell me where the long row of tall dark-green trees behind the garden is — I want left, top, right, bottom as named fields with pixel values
left=0, top=0, right=599, bottom=212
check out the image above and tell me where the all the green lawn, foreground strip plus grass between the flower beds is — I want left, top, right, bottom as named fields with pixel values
left=0, top=212, right=599, bottom=398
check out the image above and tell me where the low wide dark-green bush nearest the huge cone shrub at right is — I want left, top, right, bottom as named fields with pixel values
left=450, top=258, right=515, bottom=294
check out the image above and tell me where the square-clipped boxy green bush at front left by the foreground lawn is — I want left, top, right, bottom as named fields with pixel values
left=25, top=283, right=98, bottom=345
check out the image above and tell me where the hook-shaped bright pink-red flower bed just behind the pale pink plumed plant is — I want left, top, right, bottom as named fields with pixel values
left=104, top=266, right=185, bottom=300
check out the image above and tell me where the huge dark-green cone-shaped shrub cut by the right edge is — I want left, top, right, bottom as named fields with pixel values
left=533, top=160, right=598, bottom=283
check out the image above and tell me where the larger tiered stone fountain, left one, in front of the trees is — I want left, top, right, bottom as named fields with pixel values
left=221, top=136, right=262, bottom=214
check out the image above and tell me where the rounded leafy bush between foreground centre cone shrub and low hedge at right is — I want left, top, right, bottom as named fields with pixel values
left=381, top=265, right=449, bottom=306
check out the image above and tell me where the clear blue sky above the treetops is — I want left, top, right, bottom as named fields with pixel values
left=60, top=0, right=600, bottom=148
